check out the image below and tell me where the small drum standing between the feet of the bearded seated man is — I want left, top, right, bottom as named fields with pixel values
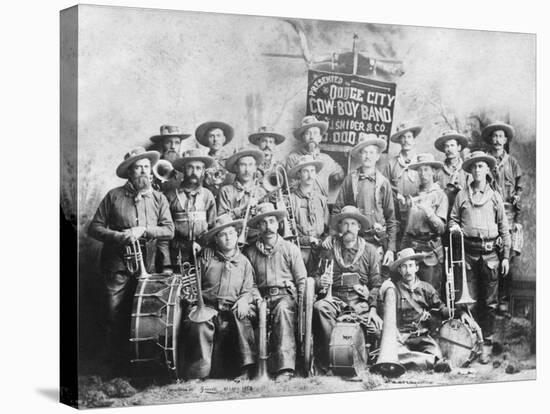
left=329, top=322, right=368, bottom=377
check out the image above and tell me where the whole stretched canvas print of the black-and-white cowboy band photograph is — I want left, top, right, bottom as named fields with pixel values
left=60, top=5, right=537, bottom=408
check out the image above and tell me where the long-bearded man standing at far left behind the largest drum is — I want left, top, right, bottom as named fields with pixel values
left=88, top=147, right=174, bottom=374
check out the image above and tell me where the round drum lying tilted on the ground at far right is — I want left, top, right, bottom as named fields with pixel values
left=438, top=319, right=477, bottom=368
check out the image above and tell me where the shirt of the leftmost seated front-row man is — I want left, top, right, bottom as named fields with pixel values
left=201, top=251, right=257, bottom=304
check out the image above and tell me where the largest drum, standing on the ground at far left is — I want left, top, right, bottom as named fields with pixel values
left=130, top=274, right=187, bottom=379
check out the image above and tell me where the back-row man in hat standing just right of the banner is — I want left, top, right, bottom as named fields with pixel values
left=384, top=124, right=422, bottom=248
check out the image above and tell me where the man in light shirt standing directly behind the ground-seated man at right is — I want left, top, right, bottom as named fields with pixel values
left=401, top=154, right=449, bottom=294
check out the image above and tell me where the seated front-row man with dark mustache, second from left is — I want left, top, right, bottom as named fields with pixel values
left=245, top=203, right=307, bottom=382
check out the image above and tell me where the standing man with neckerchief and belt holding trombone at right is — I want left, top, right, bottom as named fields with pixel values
left=449, top=151, right=511, bottom=363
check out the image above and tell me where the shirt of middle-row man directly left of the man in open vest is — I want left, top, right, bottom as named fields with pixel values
left=290, top=187, right=329, bottom=245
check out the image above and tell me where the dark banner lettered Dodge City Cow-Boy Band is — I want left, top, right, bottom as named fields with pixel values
left=306, top=70, right=395, bottom=152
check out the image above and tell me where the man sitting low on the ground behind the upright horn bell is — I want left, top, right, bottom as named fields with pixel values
left=371, top=248, right=477, bottom=372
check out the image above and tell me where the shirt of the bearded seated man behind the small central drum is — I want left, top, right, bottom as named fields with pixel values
left=314, top=237, right=382, bottom=305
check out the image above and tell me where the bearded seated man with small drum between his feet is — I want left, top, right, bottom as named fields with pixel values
left=313, top=206, right=382, bottom=371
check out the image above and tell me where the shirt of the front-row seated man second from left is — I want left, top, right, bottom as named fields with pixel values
left=244, top=236, right=307, bottom=292
